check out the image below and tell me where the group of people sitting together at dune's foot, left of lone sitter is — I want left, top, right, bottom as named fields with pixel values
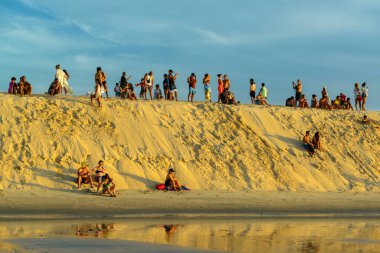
left=77, top=160, right=116, bottom=197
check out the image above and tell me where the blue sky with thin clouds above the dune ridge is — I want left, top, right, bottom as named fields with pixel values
left=0, top=0, right=380, bottom=109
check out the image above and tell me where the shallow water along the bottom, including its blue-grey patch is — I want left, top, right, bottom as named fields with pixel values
left=0, top=219, right=380, bottom=253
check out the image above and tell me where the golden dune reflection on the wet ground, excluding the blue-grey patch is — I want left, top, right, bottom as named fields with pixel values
left=0, top=219, right=380, bottom=253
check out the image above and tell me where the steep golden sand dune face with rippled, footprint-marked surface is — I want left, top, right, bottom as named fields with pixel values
left=0, top=95, right=380, bottom=192
